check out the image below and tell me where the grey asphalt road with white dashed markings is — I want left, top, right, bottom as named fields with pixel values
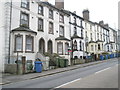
left=3, top=60, right=118, bottom=89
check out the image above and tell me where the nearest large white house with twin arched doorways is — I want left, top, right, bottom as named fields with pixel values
left=0, top=0, right=70, bottom=71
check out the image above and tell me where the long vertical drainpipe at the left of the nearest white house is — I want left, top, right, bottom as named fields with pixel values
left=8, top=0, right=12, bottom=64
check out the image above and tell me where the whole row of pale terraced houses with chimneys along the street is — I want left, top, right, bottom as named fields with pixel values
left=0, top=0, right=118, bottom=71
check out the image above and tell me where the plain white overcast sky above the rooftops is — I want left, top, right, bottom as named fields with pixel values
left=48, top=0, right=120, bottom=29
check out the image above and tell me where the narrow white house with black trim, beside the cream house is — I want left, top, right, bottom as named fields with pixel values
left=70, top=12, right=86, bottom=59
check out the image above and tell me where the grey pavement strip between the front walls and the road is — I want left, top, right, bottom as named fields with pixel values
left=0, top=58, right=118, bottom=85
